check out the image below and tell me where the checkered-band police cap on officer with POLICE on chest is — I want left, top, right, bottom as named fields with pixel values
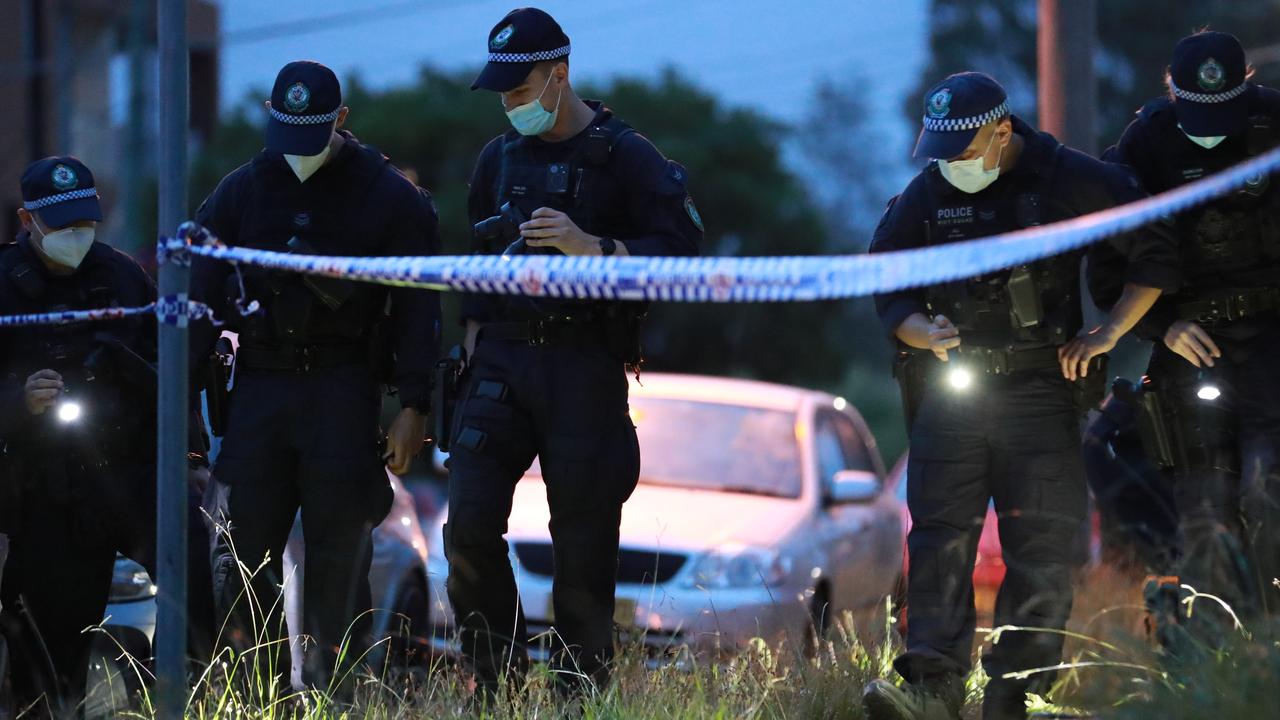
left=913, top=73, right=1009, bottom=160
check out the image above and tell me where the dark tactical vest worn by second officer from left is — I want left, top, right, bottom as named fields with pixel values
left=227, top=141, right=388, bottom=346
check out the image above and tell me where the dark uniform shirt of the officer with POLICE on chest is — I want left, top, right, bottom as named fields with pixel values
left=870, top=115, right=1179, bottom=342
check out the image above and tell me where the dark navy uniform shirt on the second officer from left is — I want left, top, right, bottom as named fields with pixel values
left=192, top=131, right=440, bottom=409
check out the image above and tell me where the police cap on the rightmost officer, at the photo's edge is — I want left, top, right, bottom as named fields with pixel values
left=1169, top=31, right=1249, bottom=137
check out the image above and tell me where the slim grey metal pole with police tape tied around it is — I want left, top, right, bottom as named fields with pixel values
left=155, top=0, right=191, bottom=719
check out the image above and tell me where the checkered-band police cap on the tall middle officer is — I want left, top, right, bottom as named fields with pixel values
left=471, top=8, right=570, bottom=92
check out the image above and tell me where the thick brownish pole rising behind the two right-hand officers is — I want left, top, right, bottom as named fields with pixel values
left=1036, top=0, right=1098, bottom=154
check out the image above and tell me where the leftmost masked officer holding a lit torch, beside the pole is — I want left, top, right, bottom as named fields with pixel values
left=0, top=156, right=212, bottom=715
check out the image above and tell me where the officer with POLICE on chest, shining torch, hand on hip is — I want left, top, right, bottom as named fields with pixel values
left=864, top=72, right=1178, bottom=720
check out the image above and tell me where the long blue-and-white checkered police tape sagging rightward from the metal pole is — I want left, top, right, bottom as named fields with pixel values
left=177, top=149, right=1280, bottom=302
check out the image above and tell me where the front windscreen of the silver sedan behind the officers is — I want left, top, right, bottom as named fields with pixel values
left=529, top=397, right=801, bottom=497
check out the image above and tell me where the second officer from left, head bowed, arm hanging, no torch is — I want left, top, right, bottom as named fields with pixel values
left=192, top=61, right=439, bottom=687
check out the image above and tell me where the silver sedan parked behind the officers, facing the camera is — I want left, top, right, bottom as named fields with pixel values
left=419, top=374, right=902, bottom=661
